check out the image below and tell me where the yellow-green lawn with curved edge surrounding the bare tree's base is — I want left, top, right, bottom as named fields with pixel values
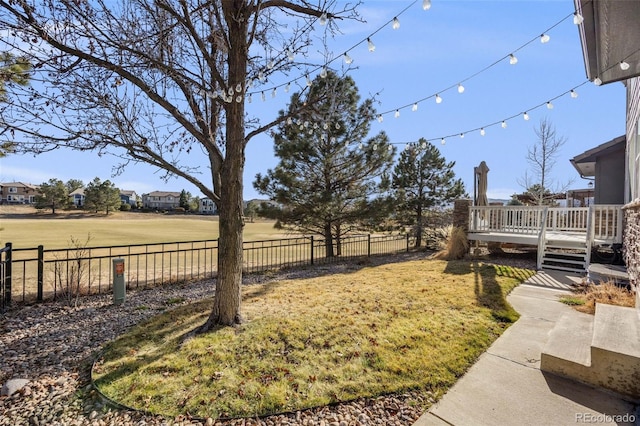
left=93, top=261, right=533, bottom=417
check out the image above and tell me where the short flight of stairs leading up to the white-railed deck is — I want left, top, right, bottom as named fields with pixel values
left=541, top=236, right=591, bottom=274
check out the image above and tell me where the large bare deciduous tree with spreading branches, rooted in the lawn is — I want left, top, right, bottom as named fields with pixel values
left=0, top=0, right=357, bottom=331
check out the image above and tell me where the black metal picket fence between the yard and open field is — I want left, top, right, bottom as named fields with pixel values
left=0, top=234, right=411, bottom=309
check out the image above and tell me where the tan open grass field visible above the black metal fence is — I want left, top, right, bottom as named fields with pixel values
left=0, top=213, right=287, bottom=249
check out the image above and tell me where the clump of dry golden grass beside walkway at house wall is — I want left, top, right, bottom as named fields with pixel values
left=560, top=281, right=636, bottom=315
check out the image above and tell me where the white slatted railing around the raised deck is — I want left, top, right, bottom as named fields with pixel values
left=469, top=205, right=622, bottom=243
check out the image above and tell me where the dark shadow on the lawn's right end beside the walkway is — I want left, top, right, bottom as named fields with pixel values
left=444, top=259, right=535, bottom=322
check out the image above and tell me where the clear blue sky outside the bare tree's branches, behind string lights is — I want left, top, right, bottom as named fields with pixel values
left=0, top=0, right=625, bottom=199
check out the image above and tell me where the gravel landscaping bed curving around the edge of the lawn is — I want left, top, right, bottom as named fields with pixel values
left=0, top=252, right=535, bottom=426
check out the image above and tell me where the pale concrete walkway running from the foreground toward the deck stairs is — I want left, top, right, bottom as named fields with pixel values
left=414, top=272, right=640, bottom=426
